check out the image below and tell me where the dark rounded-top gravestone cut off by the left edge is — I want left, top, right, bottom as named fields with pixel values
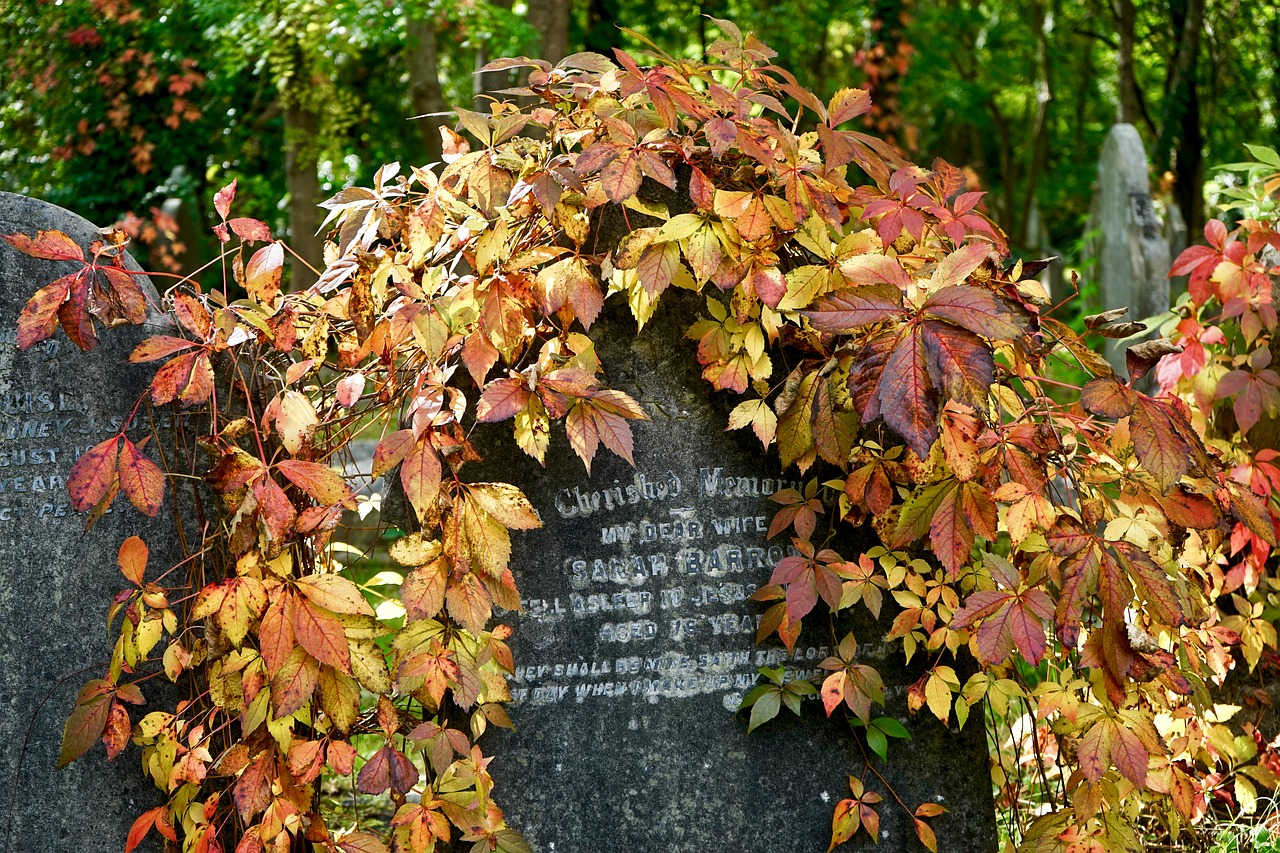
left=0, top=192, right=178, bottom=853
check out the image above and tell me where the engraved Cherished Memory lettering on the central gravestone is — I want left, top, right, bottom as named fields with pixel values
left=509, top=465, right=828, bottom=707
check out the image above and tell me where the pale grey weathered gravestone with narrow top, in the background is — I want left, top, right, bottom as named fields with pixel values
left=1085, top=123, right=1172, bottom=375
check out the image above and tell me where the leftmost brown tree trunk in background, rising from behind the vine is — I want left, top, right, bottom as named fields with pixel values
left=283, top=97, right=324, bottom=291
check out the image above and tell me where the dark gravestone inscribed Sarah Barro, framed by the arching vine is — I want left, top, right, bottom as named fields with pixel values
left=483, top=291, right=996, bottom=853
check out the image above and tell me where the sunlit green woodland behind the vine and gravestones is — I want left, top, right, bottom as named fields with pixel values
left=0, top=0, right=1280, bottom=292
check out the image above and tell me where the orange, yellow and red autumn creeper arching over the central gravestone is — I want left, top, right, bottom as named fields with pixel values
left=6, top=20, right=1276, bottom=853
